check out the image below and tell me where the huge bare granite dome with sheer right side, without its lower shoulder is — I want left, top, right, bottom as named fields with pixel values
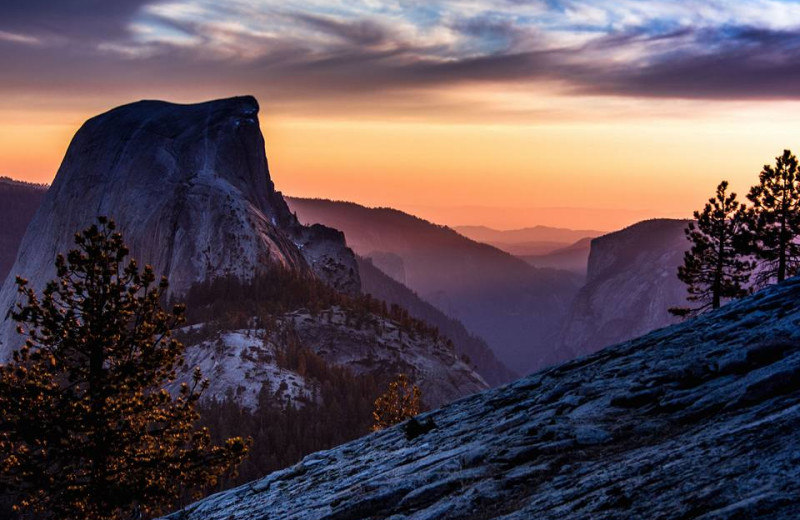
left=0, top=96, right=360, bottom=354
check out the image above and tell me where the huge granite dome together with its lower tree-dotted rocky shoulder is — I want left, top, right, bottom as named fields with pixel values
left=0, top=97, right=486, bottom=406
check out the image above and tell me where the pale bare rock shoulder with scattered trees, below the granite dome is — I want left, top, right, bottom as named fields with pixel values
left=174, top=308, right=488, bottom=409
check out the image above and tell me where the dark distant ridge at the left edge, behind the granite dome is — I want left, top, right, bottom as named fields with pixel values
left=0, top=177, right=47, bottom=285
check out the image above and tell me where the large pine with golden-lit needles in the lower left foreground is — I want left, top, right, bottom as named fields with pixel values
left=0, top=218, right=247, bottom=520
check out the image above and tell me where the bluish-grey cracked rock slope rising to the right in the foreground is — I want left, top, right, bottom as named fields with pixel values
left=162, top=279, right=800, bottom=520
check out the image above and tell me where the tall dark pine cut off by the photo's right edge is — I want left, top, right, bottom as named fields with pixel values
left=747, top=150, right=800, bottom=285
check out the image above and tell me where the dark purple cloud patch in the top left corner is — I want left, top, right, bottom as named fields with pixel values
left=0, top=0, right=154, bottom=40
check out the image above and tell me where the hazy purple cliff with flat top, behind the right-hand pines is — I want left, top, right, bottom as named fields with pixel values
left=551, top=219, right=690, bottom=362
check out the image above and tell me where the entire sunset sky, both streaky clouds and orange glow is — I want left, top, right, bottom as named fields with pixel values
left=0, top=0, right=800, bottom=230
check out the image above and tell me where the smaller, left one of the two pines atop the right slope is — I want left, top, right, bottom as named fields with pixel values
left=670, top=181, right=753, bottom=316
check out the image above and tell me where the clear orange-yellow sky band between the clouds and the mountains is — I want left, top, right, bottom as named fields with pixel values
left=0, top=94, right=800, bottom=230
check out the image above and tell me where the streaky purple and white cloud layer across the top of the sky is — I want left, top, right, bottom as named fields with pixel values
left=0, top=0, right=800, bottom=112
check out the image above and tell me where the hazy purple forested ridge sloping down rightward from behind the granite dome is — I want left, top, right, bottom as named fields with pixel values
left=288, top=198, right=581, bottom=374
